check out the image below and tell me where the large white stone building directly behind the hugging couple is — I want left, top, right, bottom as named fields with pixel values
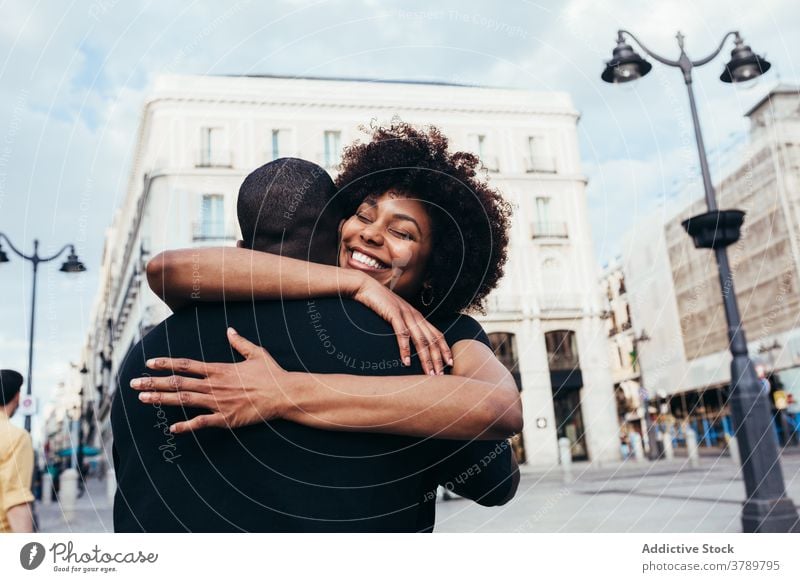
left=79, top=76, right=619, bottom=466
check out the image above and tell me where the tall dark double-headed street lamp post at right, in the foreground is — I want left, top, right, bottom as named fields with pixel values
left=601, top=30, right=800, bottom=532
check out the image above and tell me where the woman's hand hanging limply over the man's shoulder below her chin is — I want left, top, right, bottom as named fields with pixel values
left=353, top=276, right=453, bottom=375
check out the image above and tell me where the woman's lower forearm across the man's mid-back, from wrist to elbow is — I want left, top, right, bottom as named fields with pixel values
left=284, top=373, right=522, bottom=440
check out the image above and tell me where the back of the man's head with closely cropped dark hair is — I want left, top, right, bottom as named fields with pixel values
left=237, top=158, right=341, bottom=264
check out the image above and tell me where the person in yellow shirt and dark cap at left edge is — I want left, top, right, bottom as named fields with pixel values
left=0, top=370, right=33, bottom=533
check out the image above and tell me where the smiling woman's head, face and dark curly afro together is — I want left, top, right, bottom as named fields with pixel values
left=336, top=122, right=511, bottom=315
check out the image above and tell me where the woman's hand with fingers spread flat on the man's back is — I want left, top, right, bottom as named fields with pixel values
left=131, top=327, right=290, bottom=434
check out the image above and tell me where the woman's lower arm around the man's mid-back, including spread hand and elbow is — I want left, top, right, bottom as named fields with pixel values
left=131, top=329, right=522, bottom=440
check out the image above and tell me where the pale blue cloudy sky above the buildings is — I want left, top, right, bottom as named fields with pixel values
left=0, top=0, right=800, bottom=428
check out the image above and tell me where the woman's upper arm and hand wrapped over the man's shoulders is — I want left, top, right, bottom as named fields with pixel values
left=147, top=247, right=452, bottom=374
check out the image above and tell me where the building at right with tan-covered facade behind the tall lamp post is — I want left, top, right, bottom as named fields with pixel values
left=624, top=85, right=800, bottom=446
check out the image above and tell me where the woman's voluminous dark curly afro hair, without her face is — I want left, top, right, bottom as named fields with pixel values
left=336, top=120, right=511, bottom=315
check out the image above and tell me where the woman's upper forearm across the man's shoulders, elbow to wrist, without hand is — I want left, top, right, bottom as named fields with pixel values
left=147, top=247, right=363, bottom=309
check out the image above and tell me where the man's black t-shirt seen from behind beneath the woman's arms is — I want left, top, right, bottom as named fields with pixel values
left=111, top=299, right=510, bottom=532
